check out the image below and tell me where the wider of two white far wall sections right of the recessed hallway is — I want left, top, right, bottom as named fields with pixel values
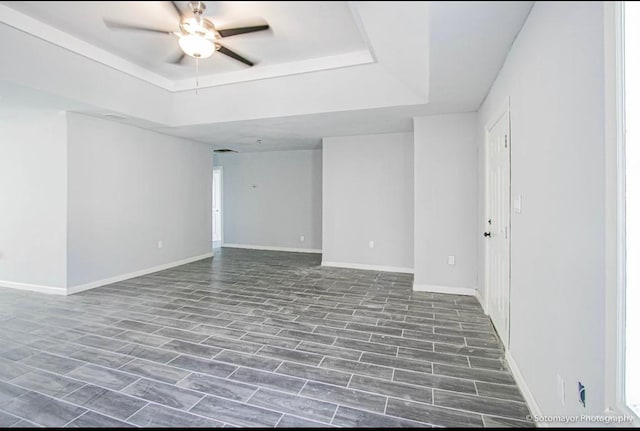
left=322, top=133, right=413, bottom=272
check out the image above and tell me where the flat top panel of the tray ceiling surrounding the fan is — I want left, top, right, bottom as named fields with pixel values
left=2, top=1, right=370, bottom=85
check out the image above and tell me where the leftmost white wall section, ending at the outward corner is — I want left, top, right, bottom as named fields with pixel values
left=0, top=112, right=67, bottom=290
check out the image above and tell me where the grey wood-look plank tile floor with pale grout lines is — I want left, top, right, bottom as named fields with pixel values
left=0, top=248, right=534, bottom=428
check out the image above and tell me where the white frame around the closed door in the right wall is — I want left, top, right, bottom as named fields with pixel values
left=480, top=97, right=513, bottom=348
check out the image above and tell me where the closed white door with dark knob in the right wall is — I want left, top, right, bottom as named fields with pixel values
left=484, top=106, right=511, bottom=347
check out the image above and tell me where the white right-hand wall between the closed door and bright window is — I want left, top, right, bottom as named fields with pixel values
left=477, top=2, right=605, bottom=422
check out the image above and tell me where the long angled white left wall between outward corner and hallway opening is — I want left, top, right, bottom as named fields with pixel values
left=68, top=113, right=213, bottom=287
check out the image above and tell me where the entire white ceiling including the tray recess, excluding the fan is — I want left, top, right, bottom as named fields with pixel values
left=0, top=1, right=532, bottom=151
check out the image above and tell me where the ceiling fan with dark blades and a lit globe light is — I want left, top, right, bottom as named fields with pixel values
left=104, top=1, right=269, bottom=66
